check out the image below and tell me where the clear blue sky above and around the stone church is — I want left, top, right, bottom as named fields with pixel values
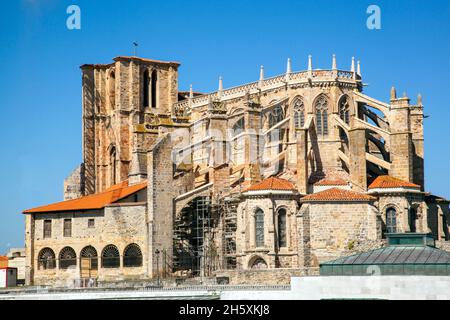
left=0, top=0, right=450, bottom=253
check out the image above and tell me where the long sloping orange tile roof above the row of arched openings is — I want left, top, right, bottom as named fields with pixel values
left=23, top=181, right=147, bottom=213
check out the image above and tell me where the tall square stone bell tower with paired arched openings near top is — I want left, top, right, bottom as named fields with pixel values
left=75, top=56, right=179, bottom=195
